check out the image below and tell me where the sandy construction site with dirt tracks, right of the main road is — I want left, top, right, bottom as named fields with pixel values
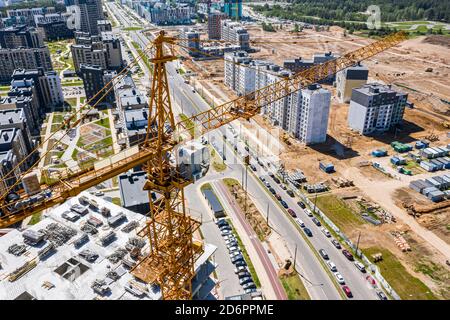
left=162, top=25, right=450, bottom=298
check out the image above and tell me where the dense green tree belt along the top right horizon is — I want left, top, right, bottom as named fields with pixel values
left=254, top=0, right=450, bottom=22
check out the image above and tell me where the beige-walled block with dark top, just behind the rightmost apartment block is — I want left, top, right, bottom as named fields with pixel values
left=336, top=63, right=369, bottom=103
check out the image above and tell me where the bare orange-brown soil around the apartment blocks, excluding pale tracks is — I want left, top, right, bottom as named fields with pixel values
left=177, top=26, right=450, bottom=299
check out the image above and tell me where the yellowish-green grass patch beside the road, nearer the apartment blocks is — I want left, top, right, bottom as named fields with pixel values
left=310, top=195, right=365, bottom=230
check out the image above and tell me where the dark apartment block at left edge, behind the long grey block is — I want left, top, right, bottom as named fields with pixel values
left=0, top=25, right=44, bottom=49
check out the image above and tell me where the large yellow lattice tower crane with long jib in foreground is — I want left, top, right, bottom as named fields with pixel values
left=0, top=31, right=406, bottom=300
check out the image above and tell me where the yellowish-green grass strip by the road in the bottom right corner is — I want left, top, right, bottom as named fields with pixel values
left=362, top=247, right=437, bottom=300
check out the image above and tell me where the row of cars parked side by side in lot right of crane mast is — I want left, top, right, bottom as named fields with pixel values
left=216, top=218, right=256, bottom=293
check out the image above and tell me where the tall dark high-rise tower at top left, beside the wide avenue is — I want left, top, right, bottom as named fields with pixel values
left=74, top=0, right=105, bottom=35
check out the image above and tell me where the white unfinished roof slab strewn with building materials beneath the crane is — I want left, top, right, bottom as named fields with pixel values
left=0, top=192, right=216, bottom=300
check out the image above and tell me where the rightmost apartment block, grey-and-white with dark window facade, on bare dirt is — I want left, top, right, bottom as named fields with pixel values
left=348, top=83, right=408, bottom=135
